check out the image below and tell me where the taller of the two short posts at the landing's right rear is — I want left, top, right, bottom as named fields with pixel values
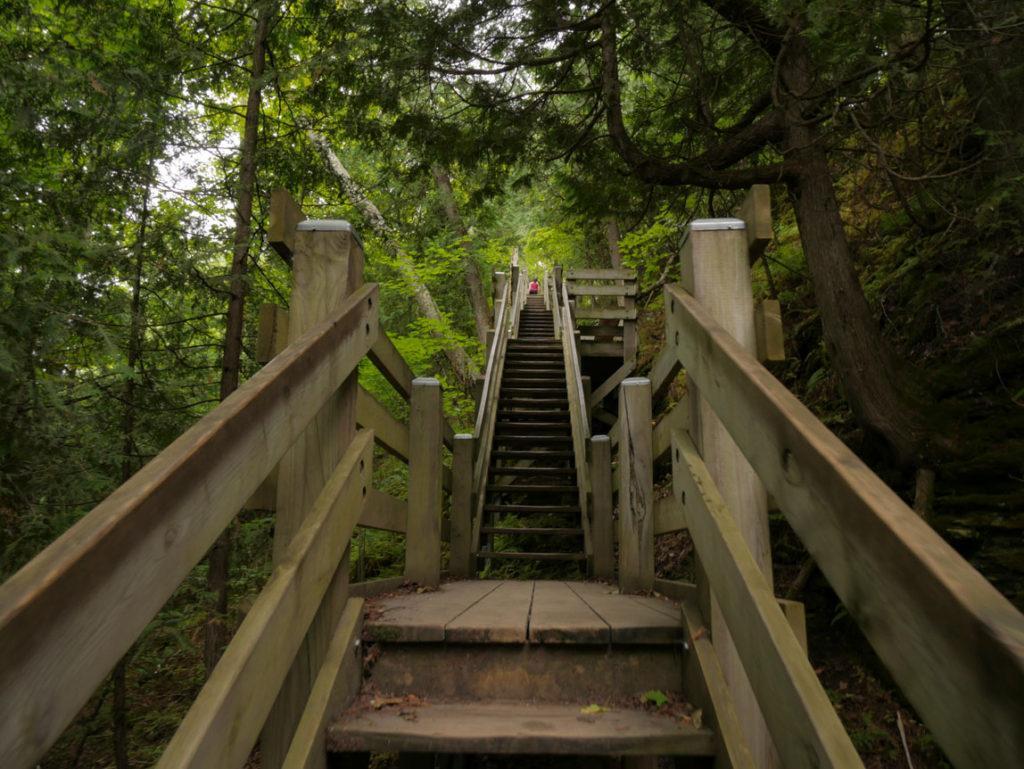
left=618, top=378, right=654, bottom=592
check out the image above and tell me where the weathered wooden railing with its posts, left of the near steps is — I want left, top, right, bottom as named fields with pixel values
left=0, top=191, right=456, bottom=769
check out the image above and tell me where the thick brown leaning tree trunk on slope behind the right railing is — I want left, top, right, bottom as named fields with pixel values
left=779, top=34, right=927, bottom=465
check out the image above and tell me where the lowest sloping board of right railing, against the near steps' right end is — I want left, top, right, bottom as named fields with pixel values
left=680, top=601, right=757, bottom=769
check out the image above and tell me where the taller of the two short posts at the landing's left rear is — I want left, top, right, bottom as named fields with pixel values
left=406, top=377, right=441, bottom=587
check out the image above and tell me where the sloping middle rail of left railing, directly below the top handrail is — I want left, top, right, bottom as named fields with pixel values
left=157, top=431, right=373, bottom=769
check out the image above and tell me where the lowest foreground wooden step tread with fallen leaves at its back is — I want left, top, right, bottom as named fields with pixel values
left=328, top=697, right=715, bottom=756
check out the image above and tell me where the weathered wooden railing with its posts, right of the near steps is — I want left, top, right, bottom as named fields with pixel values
left=591, top=189, right=1024, bottom=769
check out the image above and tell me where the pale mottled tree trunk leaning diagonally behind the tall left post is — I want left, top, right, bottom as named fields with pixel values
left=308, top=131, right=479, bottom=388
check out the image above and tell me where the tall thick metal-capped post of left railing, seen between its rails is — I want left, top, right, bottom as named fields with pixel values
left=260, top=207, right=364, bottom=769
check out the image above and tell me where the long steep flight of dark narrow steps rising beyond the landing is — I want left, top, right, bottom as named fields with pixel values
left=478, top=296, right=586, bottom=573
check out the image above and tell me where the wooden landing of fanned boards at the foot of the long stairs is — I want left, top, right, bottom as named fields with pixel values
left=364, top=580, right=683, bottom=644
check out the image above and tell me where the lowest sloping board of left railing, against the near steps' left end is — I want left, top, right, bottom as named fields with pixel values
left=284, top=598, right=364, bottom=769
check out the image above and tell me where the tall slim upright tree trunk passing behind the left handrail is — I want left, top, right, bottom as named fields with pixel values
left=203, top=2, right=273, bottom=675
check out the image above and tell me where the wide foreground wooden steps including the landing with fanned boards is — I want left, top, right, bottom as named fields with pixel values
left=327, top=581, right=717, bottom=767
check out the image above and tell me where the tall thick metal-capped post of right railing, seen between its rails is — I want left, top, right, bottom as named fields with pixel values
left=682, top=219, right=778, bottom=767
